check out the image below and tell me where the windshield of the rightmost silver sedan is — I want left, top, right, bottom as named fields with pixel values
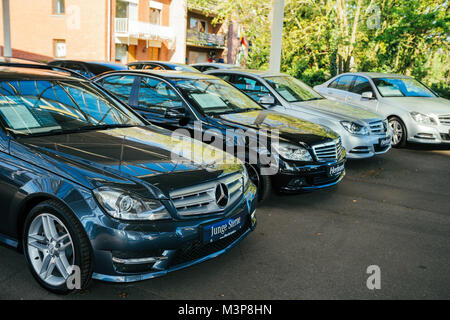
left=373, top=78, right=436, bottom=97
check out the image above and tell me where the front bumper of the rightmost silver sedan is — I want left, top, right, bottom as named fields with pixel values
left=406, top=120, right=450, bottom=144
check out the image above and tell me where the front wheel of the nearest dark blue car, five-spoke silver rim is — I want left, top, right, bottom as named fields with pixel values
left=22, top=200, right=93, bottom=294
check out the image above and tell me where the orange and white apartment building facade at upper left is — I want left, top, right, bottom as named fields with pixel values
left=0, top=0, right=187, bottom=63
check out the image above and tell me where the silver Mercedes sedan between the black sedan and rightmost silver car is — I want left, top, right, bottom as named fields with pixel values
left=205, top=69, right=391, bottom=159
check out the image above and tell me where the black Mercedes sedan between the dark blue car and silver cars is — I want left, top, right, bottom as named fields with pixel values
left=93, top=70, right=346, bottom=201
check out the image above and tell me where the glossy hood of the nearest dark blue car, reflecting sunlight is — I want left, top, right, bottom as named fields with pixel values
left=11, top=127, right=242, bottom=196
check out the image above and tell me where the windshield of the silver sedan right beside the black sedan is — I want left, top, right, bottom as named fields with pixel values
left=264, top=76, right=323, bottom=102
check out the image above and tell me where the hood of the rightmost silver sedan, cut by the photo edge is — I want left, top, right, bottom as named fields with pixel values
left=383, top=97, right=450, bottom=115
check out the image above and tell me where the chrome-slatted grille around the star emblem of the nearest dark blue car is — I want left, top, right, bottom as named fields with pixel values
left=170, top=172, right=243, bottom=216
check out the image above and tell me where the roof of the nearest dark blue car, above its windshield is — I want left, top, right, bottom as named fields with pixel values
left=0, top=66, right=83, bottom=81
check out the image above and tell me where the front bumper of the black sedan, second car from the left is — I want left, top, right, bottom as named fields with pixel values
left=272, top=158, right=346, bottom=193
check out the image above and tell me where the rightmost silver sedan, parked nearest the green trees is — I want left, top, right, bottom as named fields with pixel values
left=314, top=72, right=450, bottom=147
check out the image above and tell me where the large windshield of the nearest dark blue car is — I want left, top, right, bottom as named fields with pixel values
left=0, top=80, right=143, bottom=136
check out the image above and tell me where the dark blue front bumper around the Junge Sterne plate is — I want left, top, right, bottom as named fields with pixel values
left=85, top=185, right=257, bottom=282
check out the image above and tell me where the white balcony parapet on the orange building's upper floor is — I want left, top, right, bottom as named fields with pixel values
left=115, top=18, right=174, bottom=41
